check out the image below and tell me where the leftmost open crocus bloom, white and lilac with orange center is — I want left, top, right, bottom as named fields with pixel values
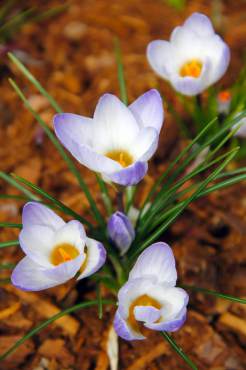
left=11, top=202, right=106, bottom=291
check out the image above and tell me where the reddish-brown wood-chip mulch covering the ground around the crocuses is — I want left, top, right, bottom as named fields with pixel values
left=0, top=0, right=246, bottom=370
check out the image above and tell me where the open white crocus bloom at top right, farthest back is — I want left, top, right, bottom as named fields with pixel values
left=147, top=13, right=230, bottom=96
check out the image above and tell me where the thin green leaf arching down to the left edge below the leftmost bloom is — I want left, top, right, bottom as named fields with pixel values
left=0, top=300, right=114, bottom=360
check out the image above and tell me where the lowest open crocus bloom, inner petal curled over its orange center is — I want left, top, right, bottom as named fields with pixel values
left=114, top=243, right=188, bottom=340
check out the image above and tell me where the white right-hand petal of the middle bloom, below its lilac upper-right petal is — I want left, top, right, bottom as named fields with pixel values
left=132, top=127, right=159, bottom=162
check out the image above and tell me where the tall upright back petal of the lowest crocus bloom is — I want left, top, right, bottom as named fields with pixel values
left=129, top=242, right=177, bottom=286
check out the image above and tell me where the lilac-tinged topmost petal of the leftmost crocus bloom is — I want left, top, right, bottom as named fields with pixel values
left=22, top=202, right=65, bottom=230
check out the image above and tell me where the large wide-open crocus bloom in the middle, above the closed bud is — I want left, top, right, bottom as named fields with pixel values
left=54, top=90, right=163, bottom=186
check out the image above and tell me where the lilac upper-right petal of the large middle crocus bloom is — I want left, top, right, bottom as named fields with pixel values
left=129, top=89, right=164, bottom=133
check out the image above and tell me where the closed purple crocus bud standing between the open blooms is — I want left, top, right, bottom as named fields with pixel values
left=108, top=211, right=135, bottom=255
